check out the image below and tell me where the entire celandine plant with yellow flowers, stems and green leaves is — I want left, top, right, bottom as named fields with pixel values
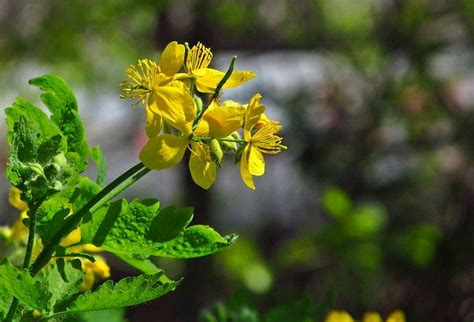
left=0, top=42, right=286, bottom=321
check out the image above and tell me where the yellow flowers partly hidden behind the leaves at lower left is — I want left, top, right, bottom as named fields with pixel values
left=8, top=188, right=110, bottom=291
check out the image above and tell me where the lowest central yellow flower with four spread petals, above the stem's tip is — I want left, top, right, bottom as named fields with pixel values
left=140, top=101, right=243, bottom=189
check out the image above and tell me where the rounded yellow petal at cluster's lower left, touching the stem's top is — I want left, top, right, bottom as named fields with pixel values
left=140, top=134, right=188, bottom=170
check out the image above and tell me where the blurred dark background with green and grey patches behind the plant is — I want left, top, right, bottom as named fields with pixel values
left=0, top=0, right=474, bottom=322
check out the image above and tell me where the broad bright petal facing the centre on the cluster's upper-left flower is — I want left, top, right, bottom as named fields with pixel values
left=149, top=81, right=196, bottom=135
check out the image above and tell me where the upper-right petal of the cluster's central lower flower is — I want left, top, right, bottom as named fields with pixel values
left=194, top=101, right=244, bottom=138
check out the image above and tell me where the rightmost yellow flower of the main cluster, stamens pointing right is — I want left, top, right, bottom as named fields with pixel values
left=240, top=94, right=286, bottom=189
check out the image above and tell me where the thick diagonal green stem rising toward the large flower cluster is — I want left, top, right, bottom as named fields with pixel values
left=30, top=162, right=150, bottom=276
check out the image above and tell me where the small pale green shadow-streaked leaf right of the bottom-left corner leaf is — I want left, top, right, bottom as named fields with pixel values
left=39, top=258, right=84, bottom=310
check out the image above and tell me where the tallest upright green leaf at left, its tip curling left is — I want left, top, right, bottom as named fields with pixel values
left=29, top=75, right=89, bottom=173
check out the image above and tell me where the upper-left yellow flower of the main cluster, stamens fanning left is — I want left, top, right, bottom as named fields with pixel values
left=120, top=41, right=194, bottom=137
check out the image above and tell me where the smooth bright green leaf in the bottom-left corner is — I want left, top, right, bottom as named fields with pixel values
left=0, top=260, right=51, bottom=310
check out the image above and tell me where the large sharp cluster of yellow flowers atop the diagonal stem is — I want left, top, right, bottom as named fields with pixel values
left=120, top=41, right=286, bottom=189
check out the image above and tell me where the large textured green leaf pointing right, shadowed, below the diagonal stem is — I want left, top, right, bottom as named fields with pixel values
left=81, top=199, right=236, bottom=258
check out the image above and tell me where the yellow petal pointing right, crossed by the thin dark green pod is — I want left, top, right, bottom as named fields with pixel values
left=191, top=68, right=255, bottom=93
